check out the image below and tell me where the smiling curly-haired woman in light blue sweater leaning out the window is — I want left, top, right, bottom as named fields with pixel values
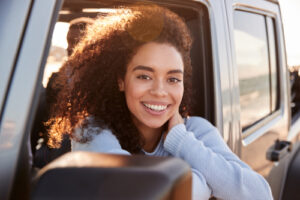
left=49, top=3, right=272, bottom=200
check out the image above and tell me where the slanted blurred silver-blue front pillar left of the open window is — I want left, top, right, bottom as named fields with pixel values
left=0, top=0, right=62, bottom=200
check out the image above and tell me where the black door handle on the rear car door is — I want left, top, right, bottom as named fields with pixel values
left=267, top=139, right=292, bottom=161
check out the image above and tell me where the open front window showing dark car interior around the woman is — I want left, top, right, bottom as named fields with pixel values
left=31, top=0, right=215, bottom=167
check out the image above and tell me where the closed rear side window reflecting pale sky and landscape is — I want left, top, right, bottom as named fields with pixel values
left=234, top=10, right=279, bottom=130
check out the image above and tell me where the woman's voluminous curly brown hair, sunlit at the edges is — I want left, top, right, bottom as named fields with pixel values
left=46, top=5, right=192, bottom=153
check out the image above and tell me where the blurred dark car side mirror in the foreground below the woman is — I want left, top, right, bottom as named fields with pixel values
left=31, top=152, right=192, bottom=200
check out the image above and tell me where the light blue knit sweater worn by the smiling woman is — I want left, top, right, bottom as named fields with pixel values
left=72, top=117, right=273, bottom=200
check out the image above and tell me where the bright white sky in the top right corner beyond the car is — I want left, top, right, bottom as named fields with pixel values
left=279, top=0, right=300, bottom=66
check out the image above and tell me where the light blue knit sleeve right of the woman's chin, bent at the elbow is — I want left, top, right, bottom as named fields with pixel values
left=164, top=117, right=272, bottom=200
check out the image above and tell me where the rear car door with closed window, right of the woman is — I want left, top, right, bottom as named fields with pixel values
left=225, top=0, right=289, bottom=199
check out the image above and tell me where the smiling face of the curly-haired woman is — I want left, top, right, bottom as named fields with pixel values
left=119, top=42, right=184, bottom=130
